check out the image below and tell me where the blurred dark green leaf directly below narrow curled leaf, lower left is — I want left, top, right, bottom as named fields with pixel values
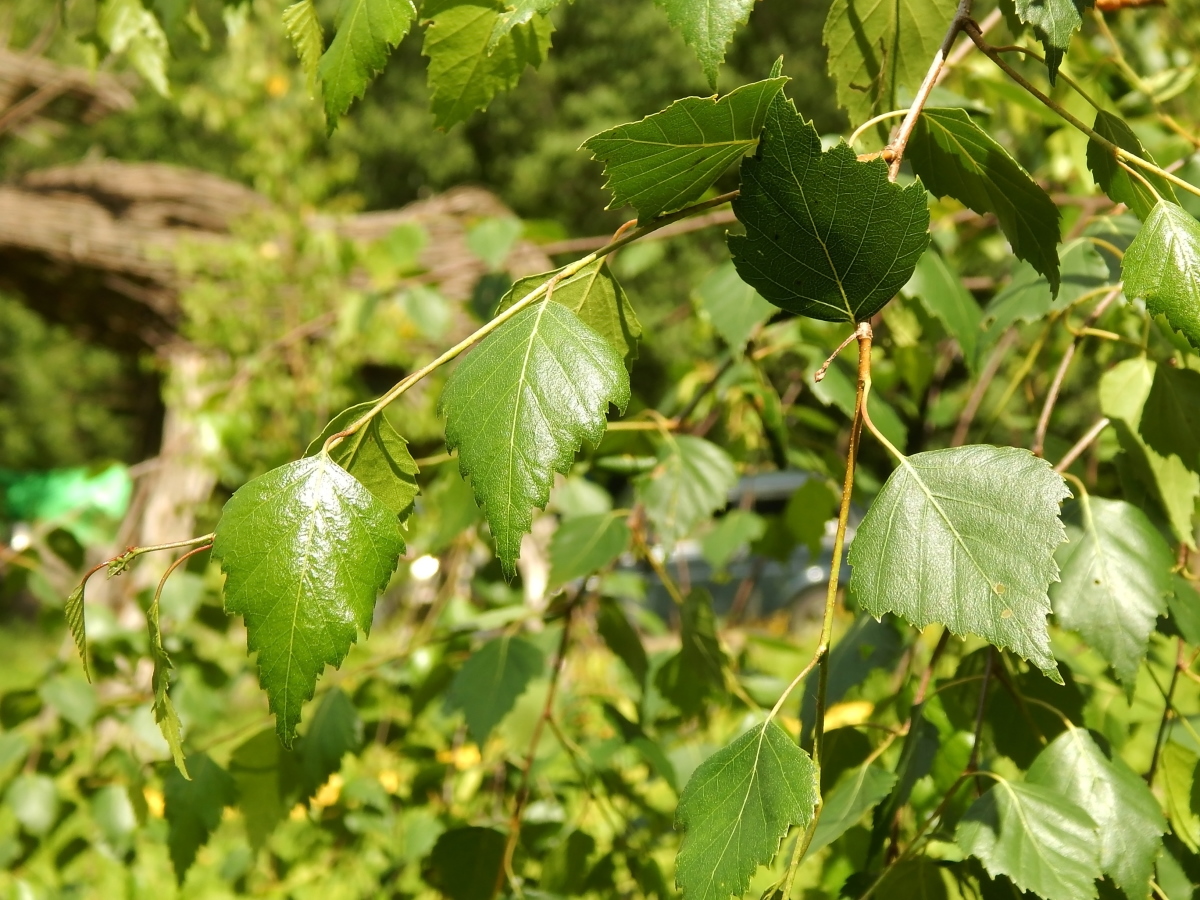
left=162, top=754, right=238, bottom=884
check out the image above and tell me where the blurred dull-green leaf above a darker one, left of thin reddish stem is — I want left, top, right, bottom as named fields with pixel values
left=446, top=636, right=545, bottom=746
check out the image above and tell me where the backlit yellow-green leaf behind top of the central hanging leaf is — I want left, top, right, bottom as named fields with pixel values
left=497, top=259, right=642, bottom=368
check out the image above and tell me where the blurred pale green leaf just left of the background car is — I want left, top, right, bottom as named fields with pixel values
left=636, top=434, right=737, bottom=546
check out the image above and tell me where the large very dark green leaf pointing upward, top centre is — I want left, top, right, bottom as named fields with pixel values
left=728, top=87, right=929, bottom=322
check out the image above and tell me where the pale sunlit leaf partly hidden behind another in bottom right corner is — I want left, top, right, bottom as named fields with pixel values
left=1026, top=728, right=1166, bottom=900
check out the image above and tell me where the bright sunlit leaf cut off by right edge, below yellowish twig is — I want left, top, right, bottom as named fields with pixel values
left=1121, top=200, right=1200, bottom=347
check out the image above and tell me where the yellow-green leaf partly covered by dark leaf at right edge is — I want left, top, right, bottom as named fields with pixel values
left=1099, top=356, right=1200, bottom=547
